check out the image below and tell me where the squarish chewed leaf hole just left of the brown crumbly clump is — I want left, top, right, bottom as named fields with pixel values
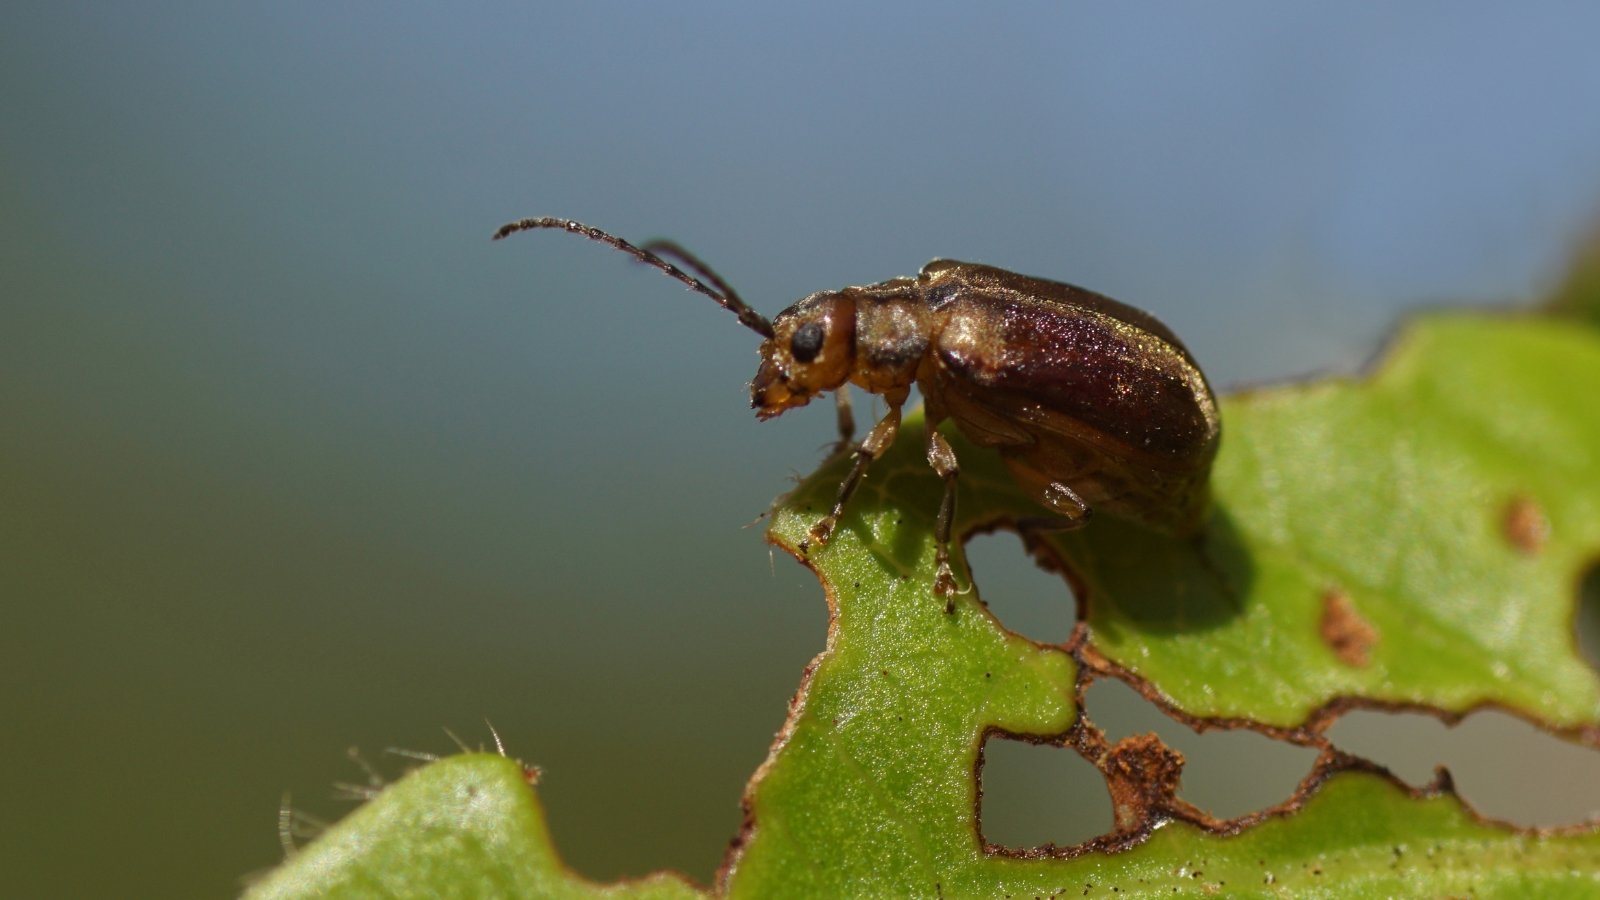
left=979, top=735, right=1112, bottom=847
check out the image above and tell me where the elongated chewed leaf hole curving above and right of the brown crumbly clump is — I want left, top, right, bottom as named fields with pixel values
left=1083, top=679, right=1317, bottom=818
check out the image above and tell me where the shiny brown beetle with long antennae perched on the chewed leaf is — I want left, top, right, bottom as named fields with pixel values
left=494, top=218, right=1221, bottom=610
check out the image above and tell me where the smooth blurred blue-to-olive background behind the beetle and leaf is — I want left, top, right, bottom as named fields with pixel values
left=0, top=2, right=1600, bottom=897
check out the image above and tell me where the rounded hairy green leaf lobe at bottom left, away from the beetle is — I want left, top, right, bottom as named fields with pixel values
left=246, top=753, right=699, bottom=900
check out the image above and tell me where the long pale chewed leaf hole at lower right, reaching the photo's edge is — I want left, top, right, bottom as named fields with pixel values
left=1328, top=709, right=1600, bottom=826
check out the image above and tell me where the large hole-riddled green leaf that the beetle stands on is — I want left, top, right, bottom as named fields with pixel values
left=730, top=307, right=1600, bottom=895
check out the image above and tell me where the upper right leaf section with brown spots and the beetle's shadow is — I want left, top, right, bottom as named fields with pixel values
left=1058, top=315, right=1600, bottom=732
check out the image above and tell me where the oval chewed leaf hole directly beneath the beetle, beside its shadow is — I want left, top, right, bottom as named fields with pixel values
left=966, top=530, right=1078, bottom=644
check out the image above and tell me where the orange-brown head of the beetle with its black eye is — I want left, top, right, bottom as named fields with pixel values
left=750, top=291, right=856, bottom=420
